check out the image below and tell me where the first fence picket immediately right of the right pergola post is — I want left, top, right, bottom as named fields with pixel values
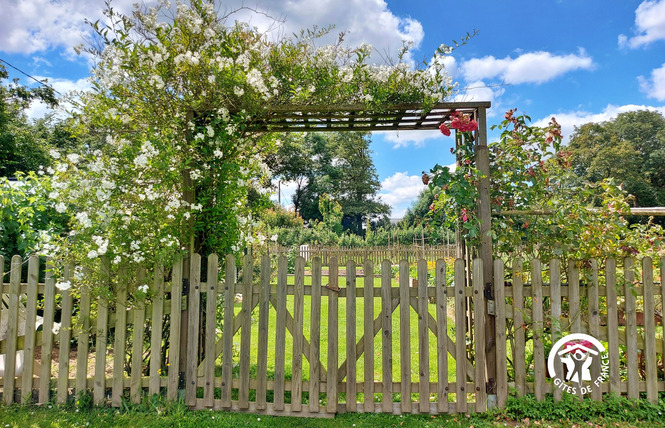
left=494, top=259, right=508, bottom=409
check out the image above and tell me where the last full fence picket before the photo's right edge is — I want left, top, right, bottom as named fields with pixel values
left=642, top=257, right=658, bottom=404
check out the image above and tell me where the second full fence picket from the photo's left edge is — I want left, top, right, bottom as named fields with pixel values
left=21, top=255, right=39, bottom=403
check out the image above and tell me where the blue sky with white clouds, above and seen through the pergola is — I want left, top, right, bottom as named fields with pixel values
left=0, top=0, right=665, bottom=217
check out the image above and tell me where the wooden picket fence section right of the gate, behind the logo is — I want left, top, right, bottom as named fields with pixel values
left=494, top=257, right=665, bottom=406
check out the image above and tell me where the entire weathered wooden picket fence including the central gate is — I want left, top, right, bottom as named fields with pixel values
left=0, top=254, right=665, bottom=417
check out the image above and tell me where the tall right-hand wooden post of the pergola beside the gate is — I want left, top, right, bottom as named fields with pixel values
left=475, top=107, right=496, bottom=408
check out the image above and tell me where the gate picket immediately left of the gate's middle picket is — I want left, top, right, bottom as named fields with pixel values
left=309, top=257, right=321, bottom=413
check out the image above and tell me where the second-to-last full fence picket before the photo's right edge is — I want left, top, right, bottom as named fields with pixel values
left=623, top=257, right=639, bottom=400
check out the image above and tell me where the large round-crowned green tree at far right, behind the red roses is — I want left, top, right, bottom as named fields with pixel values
left=569, top=110, right=665, bottom=211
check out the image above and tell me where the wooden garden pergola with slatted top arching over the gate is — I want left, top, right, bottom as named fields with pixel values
left=180, top=101, right=496, bottom=407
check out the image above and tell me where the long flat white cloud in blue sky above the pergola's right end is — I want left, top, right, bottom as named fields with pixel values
left=461, top=49, right=594, bottom=84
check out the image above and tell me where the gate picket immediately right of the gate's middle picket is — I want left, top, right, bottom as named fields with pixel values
left=346, top=260, right=357, bottom=412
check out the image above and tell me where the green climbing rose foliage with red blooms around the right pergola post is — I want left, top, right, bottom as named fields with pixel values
left=430, top=110, right=664, bottom=262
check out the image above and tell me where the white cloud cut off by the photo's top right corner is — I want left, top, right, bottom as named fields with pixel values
left=619, top=0, right=665, bottom=49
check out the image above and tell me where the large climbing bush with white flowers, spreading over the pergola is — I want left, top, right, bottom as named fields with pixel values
left=44, top=0, right=453, bottom=294
